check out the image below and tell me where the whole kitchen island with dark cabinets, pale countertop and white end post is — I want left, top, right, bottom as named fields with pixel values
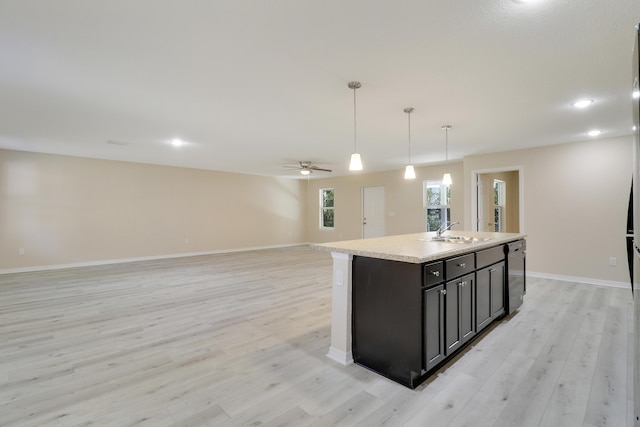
left=313, top=231, right=525, bottom=388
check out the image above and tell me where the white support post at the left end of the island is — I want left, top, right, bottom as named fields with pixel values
left=327, top=252, right=353, bottom=365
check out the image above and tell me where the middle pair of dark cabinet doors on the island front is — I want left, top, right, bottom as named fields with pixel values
left=445, top=273, right=475, bottom=355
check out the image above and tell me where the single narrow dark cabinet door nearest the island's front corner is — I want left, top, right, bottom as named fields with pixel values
left=422, top=285, right=446, bottom=371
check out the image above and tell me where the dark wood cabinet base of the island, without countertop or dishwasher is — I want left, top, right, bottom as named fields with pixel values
left=352, top=239, right=524, bottom=388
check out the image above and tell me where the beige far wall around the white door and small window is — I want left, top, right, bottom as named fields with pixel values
left=307, top=162, right=464, bottom=243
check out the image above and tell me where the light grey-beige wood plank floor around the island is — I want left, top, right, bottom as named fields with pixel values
left=0, top=246, right=633, bottom=427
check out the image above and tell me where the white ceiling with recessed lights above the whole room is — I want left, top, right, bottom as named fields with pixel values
left=0, top=0, right=640, bottom=177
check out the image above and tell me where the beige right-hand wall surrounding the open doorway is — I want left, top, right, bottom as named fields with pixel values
left=464, top=136, right=632, bottom=282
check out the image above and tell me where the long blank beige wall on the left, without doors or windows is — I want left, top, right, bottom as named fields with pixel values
left=0, top=150, right=306, bottom=269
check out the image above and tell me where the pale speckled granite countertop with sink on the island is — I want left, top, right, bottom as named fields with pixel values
left=311, top=230, right=526, bottom=264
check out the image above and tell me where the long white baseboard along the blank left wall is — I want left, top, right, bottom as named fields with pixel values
left=0, top=243, right=309, bottom=274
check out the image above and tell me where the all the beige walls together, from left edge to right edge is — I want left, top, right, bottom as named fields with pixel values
left=0, top=137, right=632, bottom=282
